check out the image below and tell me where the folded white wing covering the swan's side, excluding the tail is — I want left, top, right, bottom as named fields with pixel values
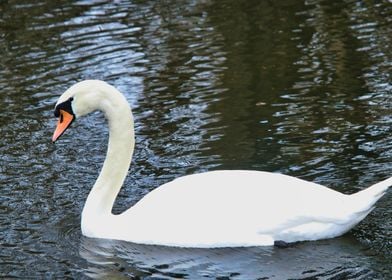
left=121, top=171, right=345, bottom=246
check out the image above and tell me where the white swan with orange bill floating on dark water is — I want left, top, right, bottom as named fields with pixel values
left=52, top=80, right=392, bottom=248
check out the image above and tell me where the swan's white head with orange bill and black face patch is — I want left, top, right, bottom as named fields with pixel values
left=52, top=80, right=111, bottom=143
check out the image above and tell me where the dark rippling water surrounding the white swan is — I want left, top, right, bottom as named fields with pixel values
left=0, top=0, right=392, bottom=279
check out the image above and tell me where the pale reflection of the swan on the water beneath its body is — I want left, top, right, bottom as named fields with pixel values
left=80, top=235, right=382, bottom=279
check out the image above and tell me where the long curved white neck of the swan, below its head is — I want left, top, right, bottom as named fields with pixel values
left=82, top=86, right=135, bottom=230
